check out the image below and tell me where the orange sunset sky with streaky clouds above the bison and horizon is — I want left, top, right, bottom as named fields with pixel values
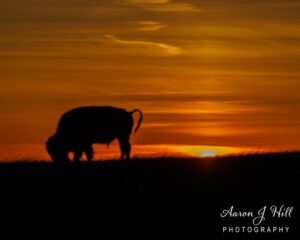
left=0, top=0, right=300, bottom=160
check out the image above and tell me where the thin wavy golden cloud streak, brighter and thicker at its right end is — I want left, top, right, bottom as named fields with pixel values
left=105, top=35, right=181, bottom=56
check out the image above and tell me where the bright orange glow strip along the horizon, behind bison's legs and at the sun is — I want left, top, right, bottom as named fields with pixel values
left=0, top=142, right=255, bottom=162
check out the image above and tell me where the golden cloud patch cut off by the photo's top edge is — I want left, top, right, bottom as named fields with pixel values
left=126, top=0, right=201, bottom=13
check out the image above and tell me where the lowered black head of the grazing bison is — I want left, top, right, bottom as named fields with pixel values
left=46, top=135, right=69, bottom=163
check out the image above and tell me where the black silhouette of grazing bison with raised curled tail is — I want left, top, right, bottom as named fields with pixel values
left=46, top=106, right=143, bottom=163
